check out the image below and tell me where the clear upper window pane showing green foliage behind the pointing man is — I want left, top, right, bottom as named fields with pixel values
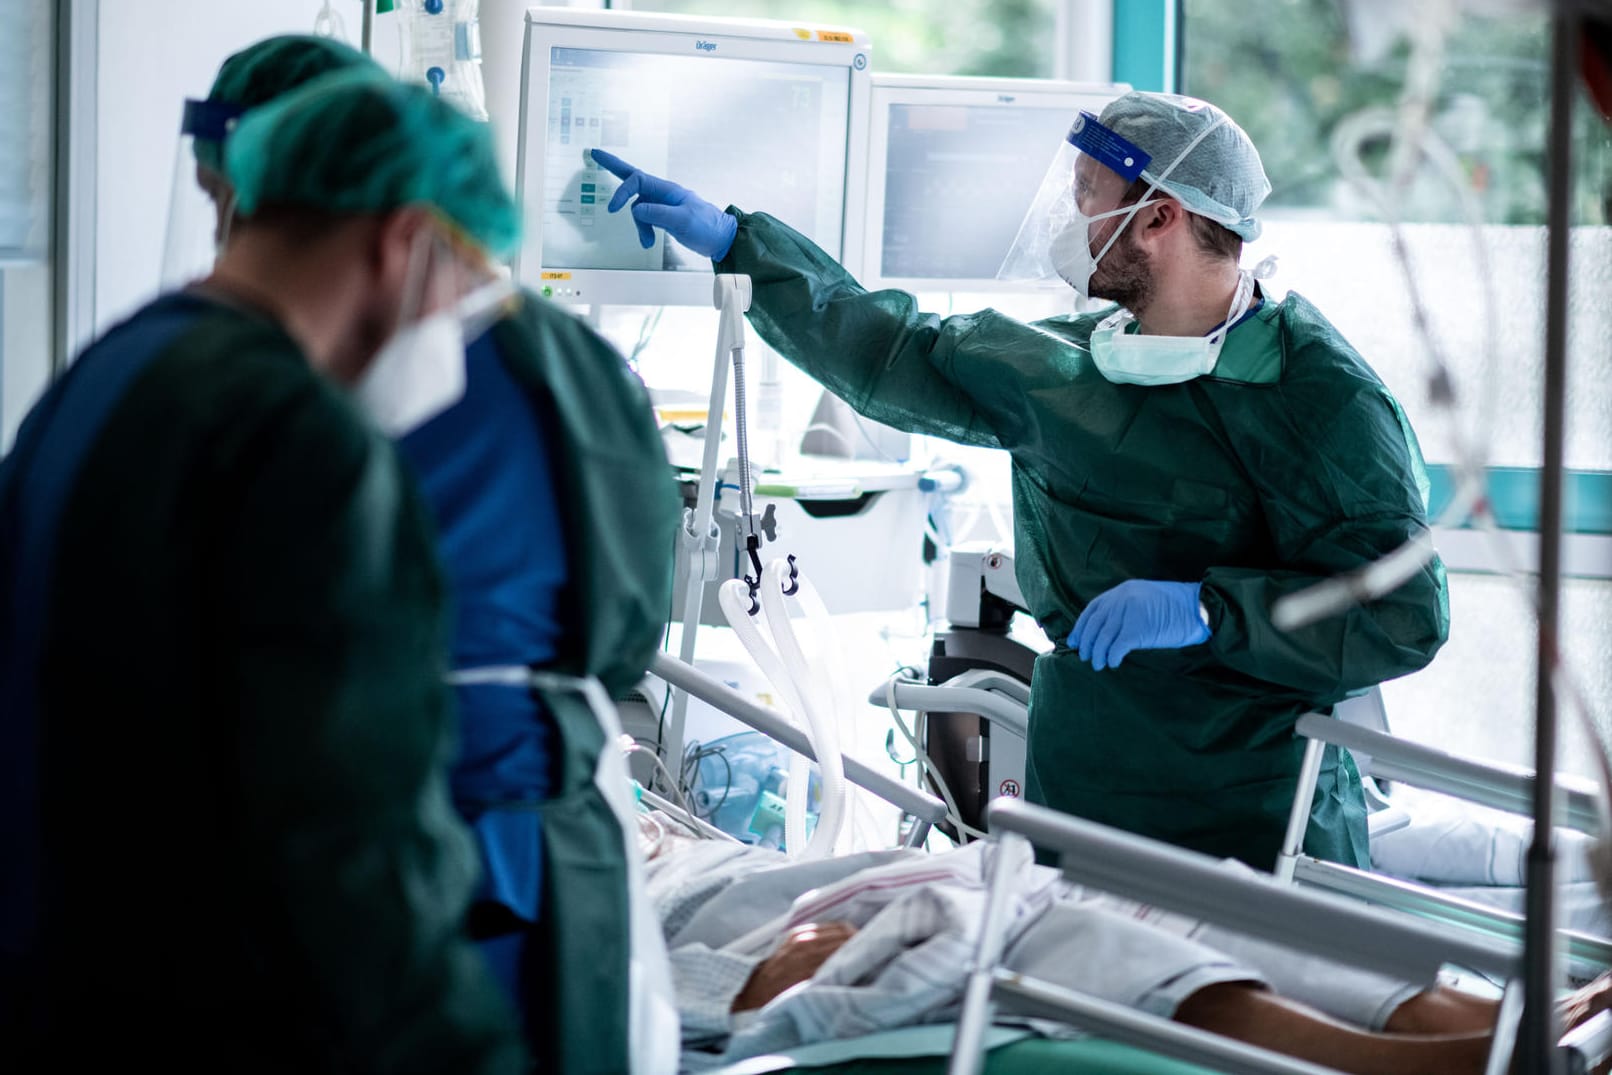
left=1182, top=0, right=1612, bottom=224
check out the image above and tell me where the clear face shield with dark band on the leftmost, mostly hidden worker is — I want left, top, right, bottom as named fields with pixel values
left=161, top=100, right=243, bottom=292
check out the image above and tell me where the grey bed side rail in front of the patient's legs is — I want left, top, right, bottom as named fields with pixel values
left=949, top=799, right=1612, bottom=1075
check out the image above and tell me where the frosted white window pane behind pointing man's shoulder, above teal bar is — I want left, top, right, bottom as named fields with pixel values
left=1263, top=216, right=1612, bottom=471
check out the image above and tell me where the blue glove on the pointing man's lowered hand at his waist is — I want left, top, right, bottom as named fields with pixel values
left=1069, top=579, right=1209, bottom=672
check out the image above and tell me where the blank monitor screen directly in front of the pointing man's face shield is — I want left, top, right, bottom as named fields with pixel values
left=879, top=103, right=1075, bottom=280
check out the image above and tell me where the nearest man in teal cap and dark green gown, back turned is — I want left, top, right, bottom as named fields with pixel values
left=0, top=71, right=527, bottom=1072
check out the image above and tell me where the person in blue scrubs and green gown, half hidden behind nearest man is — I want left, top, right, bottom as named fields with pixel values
left=169, top=37, right=679, bottom=1072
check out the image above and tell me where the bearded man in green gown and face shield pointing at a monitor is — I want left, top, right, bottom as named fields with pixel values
left=595, top=93, right=1449, bottom=869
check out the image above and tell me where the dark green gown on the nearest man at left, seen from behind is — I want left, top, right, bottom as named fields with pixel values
left=6, top=295, right=526, bottom=1073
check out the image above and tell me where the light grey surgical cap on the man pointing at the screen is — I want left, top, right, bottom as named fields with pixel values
left=1101, top=92, right=1270, bottom=240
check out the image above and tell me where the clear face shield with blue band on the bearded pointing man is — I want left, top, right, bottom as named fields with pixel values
left=996, top=111, right=1219, bottom=295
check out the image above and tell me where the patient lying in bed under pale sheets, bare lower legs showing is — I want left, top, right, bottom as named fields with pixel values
left=643, top=814, right=1612, bottom=1075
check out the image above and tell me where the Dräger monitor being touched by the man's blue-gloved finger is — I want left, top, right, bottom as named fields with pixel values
left=516, top=8, right=870, bottom=306
